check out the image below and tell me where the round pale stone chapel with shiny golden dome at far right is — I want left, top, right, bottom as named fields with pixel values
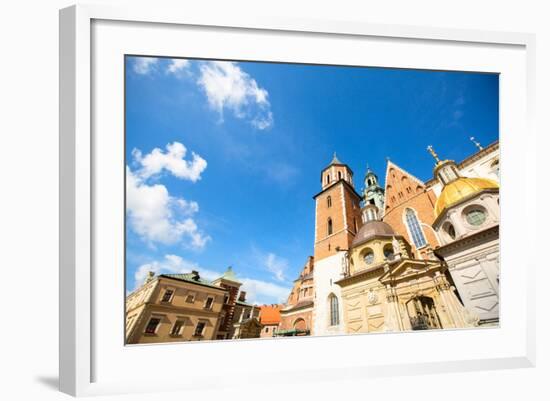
left=433, top=153, right=500, bottom=324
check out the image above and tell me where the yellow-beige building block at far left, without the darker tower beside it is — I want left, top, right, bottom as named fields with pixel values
left=126, top=271, right=227, bottom=344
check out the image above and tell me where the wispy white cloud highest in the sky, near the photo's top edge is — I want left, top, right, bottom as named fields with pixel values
left=198, top=61, right=273, bottom=130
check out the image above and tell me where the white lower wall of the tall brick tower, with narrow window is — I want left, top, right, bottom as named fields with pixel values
left=312, top=251, right=346, bottom=336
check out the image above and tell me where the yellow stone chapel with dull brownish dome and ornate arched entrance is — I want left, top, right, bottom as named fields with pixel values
left=331, top=205, right=474, bottom=333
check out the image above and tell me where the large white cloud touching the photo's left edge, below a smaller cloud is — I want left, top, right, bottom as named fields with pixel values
left=126, top=167, right=210, bottom=249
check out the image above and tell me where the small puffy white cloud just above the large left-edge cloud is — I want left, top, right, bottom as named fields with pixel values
left=132, top=142, right=207, bottom=182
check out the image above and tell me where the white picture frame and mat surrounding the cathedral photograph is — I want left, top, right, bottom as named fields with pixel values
left=60, top=5, right=536, bottom=396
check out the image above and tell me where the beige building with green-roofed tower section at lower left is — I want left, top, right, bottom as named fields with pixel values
left=126, top=268, right=261, bottom=344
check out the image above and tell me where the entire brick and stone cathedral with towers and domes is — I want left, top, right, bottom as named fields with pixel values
left=281, top=138, right=500, bottom=335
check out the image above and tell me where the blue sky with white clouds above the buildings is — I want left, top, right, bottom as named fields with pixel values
left=125, top=57, right=498, bottom=303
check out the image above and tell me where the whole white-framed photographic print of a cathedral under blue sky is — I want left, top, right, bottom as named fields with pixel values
left=60, top=6, right=535, bottom=395
